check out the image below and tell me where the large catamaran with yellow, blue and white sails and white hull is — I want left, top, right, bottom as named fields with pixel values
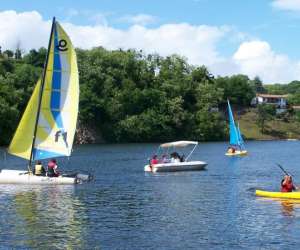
left=0, top=18, right=88, bottom=184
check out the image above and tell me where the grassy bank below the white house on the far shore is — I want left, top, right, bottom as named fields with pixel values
left=236, top=108, right=300, bottom=140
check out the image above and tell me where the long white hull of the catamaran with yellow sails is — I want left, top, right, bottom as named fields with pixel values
left=0, top=169, right=77, bottom=185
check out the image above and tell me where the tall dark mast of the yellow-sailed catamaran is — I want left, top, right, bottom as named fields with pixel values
left=28, top=17, right=55, bottom=172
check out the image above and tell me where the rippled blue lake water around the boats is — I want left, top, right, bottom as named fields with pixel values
left=0, top=141, right=300, bottom=249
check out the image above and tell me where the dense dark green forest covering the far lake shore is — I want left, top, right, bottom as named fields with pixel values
left=0, top=47, right=300, bottom=145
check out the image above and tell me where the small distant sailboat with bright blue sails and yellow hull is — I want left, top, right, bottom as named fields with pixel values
left=225, top=100, right=247, bottom=156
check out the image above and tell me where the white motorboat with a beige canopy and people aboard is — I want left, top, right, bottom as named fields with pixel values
left=144, top=141, right=207, bottom=173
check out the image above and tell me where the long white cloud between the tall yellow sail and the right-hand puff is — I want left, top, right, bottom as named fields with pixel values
left=64, top=24, right=226, bottom=65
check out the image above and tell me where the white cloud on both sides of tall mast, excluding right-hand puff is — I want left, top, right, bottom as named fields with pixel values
left=0, top=11, right=230, bottom=65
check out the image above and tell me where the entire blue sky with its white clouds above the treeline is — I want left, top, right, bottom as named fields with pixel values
left=0, top=0, right=300, bottom=82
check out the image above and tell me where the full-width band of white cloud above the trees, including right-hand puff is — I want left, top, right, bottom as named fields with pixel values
left=0, top=11, right=300, bottom=83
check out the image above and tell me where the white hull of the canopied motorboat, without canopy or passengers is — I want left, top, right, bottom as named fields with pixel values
left=144, top=161, right=207, bottom=173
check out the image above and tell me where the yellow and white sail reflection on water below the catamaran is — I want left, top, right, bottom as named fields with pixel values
left=0, top=185, right=85, bottom=249
